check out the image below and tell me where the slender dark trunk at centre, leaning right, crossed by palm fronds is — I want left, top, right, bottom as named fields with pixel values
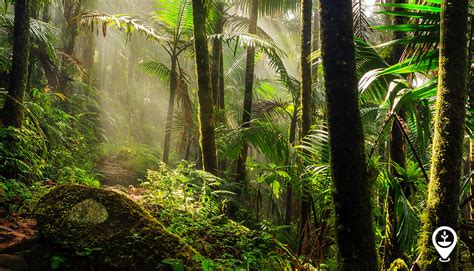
left=235, top=0, right=259, bottom=195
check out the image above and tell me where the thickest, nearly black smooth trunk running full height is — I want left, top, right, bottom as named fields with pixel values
left=320, top=0, right=378, bottom=270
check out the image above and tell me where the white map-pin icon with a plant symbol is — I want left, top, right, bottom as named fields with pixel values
left=431, top=226, right=458, bottom=263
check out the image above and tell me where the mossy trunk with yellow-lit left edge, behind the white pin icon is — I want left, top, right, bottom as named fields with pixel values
left=421, top=0, right=468, bottom=271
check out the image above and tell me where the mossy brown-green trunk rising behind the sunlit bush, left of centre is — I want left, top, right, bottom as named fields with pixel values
left=193, top=0, right=217, bottom=174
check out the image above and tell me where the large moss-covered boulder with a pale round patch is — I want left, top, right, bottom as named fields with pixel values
left=35, top=185, right=198, bottom=270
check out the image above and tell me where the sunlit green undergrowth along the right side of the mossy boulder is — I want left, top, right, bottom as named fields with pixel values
left=142, top=163, right=291, bottom=270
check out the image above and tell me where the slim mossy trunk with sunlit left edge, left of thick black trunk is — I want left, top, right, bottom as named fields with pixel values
left=299, top=0, right=313, bottom=255
